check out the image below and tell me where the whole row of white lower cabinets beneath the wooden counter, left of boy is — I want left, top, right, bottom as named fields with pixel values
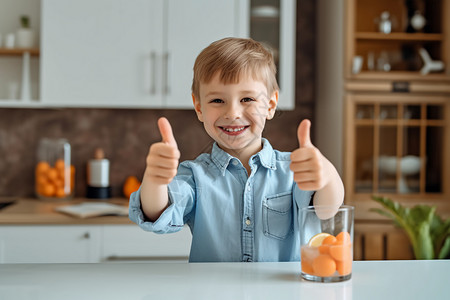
left=0, top=225, right=191, bottom=263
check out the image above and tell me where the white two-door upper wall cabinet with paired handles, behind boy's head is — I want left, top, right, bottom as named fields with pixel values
left=40, top=0, right=240, bottom=108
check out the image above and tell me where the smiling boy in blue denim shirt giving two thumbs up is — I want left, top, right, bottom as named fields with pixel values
left=130, top=38, right=344, bottom=262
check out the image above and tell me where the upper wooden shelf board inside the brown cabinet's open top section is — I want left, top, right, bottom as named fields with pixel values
left=355, top=32, right=444, bottom=42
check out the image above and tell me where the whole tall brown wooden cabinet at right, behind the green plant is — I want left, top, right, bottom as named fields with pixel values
left=344, top=0, right=450, bottom=259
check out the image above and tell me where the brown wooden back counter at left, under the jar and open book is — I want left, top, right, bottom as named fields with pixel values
left=0, top=198, right=133, bottom=226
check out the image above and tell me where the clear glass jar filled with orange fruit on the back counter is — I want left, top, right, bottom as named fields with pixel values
left=35, top=138, right=75, bottom=200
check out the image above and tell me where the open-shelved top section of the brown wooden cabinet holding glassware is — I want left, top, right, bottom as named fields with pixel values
left=345, top=0, right=450, bottom=81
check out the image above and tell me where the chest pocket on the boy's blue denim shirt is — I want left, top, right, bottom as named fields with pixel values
left=263, top=192, right=294, bottom=240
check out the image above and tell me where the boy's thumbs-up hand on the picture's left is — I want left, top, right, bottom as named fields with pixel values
left=144, top=117, right=180, bottom=185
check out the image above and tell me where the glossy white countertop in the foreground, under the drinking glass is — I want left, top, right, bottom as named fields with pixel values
left=0, top=260, right=450, bottom=300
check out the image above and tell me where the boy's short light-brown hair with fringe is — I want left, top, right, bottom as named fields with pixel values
left=192, top=38, right=279, bottom=99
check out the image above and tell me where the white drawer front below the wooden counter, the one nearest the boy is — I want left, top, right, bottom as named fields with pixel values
left=101, top=225, right=192, bottom=262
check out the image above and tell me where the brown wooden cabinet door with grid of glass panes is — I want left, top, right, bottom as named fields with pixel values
left=345, top=94, right=450, bottom=201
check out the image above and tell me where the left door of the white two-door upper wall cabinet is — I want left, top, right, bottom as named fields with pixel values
left=41, top=0, right=163, bottom=107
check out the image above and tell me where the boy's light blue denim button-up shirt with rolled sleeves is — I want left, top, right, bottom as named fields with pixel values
left=129, top=139, right=313, bottom=262
